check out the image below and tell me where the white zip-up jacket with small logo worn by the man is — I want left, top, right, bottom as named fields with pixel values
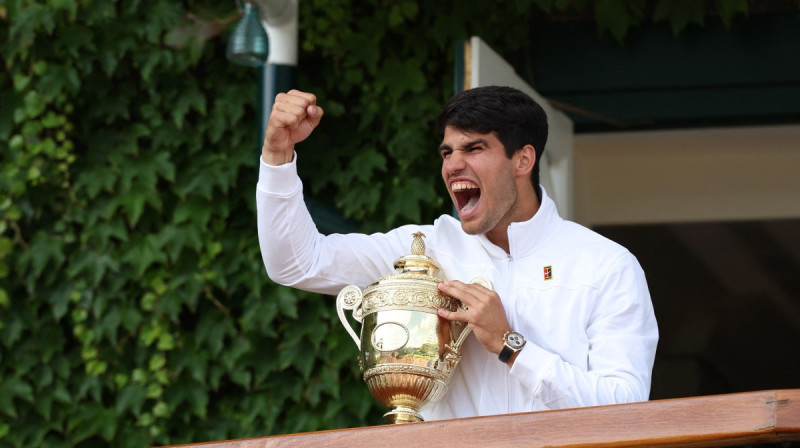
left=256, top=155, right=658, bottom=420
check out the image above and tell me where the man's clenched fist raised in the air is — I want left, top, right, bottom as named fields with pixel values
left=261, top=90, right=324, bottom=165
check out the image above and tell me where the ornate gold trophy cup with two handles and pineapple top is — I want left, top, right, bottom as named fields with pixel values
left=336, top=232, right=491, bottom=423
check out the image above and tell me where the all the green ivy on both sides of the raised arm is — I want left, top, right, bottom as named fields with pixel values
left=0, top=0, right=776, bottom=447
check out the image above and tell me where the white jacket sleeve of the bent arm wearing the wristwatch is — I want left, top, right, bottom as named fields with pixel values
left=511, top=252, right=658, bottom=409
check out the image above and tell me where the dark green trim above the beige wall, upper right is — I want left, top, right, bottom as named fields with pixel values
left=518, top=14, right=800, bottom=132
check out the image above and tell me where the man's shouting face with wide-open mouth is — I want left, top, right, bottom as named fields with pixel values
left=439, top=126, right=517, bottom=239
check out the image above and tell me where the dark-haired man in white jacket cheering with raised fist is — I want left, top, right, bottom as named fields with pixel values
left=256, top=87, right=658, bottom=420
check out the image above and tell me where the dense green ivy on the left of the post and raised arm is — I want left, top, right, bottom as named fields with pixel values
left=0, top=0, right=379, bottom=447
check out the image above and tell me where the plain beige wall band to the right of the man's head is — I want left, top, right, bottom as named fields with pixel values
left=573, top=125, right=800, bottom=226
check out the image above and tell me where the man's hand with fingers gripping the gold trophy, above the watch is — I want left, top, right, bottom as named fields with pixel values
left=439, top=280, right=511, bottom=363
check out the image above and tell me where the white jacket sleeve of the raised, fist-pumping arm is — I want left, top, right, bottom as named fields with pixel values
left=256, top=154, right=411, bottom=295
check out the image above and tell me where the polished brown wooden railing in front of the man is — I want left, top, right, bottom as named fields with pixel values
left=162, top=389, right=800, bottom=448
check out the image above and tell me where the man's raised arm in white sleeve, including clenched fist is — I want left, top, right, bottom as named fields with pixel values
left=256, top=90, right=414, bottom=294
